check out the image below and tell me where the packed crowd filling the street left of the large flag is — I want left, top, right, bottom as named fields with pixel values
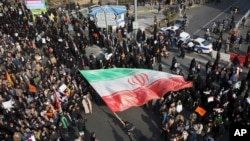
left=0, top=1, right=102, bottom=141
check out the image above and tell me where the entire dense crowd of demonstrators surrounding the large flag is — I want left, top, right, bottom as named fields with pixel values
left=0, top=1, right=250, bottom=141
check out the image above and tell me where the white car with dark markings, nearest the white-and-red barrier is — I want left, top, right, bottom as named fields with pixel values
left=179, top=37, right=213, bottom=53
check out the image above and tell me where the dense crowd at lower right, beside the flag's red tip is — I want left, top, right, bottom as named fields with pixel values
left=153, top=55, right=250, bottom=141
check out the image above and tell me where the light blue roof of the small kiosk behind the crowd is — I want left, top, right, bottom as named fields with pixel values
left=88, top=5, right=127, bottom=16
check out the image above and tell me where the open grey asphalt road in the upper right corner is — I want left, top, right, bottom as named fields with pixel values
left=186, top=0, right=250, bottom=36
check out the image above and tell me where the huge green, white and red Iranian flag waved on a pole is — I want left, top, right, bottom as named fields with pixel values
left=80, top=68, right=192, bottom=112
